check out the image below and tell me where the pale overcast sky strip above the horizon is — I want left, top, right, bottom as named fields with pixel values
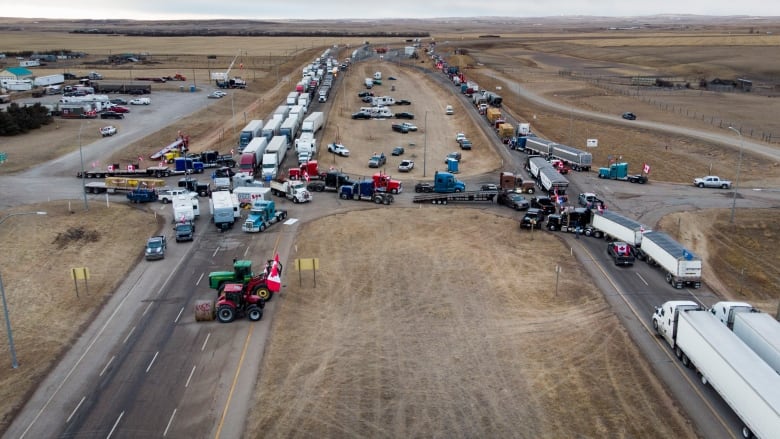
left=0, top=0, right=780, bottom=20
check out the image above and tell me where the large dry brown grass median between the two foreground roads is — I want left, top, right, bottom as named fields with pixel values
left=249, top=207, right=693, bottom=438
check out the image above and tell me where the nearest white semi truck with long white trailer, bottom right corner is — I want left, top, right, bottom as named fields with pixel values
left=652, top=300, right=780, bottom=438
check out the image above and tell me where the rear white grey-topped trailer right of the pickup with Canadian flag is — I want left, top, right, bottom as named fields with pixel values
left=640, top=232, right=701, bottom=288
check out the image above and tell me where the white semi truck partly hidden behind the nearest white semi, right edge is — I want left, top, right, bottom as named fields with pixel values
left=710, top=302, right=780, bottom=374
